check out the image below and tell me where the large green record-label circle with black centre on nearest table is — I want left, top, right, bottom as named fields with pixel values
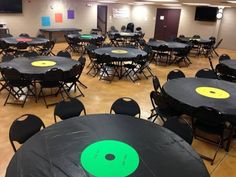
left=80, top=140, right=139, bottom=177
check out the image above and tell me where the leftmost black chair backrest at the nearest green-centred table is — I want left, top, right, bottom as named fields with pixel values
left=9, top=114, right=45, bottom=152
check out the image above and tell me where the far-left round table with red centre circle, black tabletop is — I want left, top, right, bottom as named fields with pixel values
left=1, top=37, right=48, bottom=46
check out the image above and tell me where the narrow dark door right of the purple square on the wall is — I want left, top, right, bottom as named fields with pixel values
left=97, top=5, right=107, bottom=34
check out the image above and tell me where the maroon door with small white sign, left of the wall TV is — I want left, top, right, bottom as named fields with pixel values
left=154, top=9, right=181, bottom=41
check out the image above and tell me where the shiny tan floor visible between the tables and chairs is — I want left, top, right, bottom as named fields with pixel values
left=0, top=43, right=236, bottom=177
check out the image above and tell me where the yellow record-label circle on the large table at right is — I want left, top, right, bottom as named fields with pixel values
left=196, top=87, right=230, bottom=99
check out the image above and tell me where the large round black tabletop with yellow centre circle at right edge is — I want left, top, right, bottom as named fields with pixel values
left=163, top=78, right=236, bottom=123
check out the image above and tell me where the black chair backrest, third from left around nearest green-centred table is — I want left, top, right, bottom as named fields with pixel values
left=110, top=97, right=141, bottom=118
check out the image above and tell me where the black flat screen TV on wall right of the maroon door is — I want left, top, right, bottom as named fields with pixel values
left=195, top=6, right=218, bottom=22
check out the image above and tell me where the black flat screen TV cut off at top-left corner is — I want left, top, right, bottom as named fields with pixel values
left=0, top=0, right=22, bottom=13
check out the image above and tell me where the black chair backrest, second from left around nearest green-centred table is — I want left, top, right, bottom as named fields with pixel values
left=54, top=98, right=86, bottom=122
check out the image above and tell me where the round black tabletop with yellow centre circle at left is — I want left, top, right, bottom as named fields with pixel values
left=0, top=56, right=78, bottom=79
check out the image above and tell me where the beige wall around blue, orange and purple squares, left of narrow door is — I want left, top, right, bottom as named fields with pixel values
left=0, top=0, right=97, bottom=36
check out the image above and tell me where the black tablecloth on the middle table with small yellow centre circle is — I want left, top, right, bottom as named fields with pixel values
left=94, top=47, right=147, bottom=61
